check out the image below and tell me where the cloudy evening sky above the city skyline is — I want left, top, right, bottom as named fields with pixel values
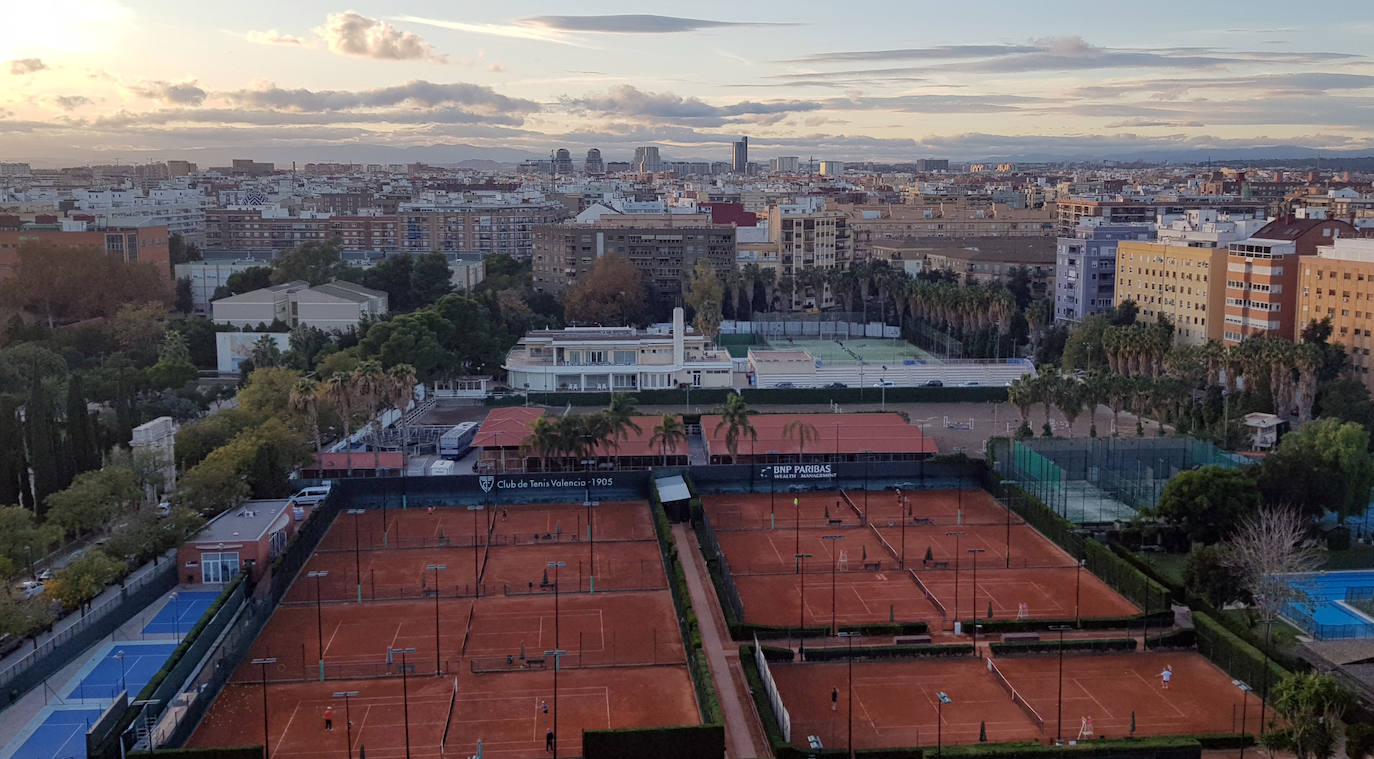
left=0, top=0, right=1374, bottom=166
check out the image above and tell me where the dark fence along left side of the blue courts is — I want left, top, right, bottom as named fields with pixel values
left=0, top=557, right=176, bottom=705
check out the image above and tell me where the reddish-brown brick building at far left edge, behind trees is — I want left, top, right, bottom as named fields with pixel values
left=0, top=216, right=172, bottom=281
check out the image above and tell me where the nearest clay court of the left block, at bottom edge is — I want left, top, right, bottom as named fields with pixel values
left=187, top=664, right=701, bottom=759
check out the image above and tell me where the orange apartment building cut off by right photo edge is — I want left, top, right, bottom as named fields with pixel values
left=1294, top=238, right=1374, bottom=391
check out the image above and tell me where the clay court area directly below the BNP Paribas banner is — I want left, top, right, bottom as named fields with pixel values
left=702, top=490, right=1139, bottom=630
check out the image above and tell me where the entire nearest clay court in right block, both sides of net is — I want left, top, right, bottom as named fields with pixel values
left=771, top=652, right=1260, bottom=749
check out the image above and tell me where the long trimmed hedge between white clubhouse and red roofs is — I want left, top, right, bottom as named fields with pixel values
left=486, top=385, right=1007, bottom=406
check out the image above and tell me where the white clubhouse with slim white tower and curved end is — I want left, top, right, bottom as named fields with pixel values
left=504, top=308, right=732, bottom=392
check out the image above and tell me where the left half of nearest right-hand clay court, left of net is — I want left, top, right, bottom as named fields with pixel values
left=769, top=657, right=1040, bottom=748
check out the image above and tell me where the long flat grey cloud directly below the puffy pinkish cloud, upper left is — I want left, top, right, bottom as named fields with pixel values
left=221, top=80, right=540, bottom=116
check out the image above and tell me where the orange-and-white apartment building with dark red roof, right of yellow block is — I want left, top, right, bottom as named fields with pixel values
left=1221, top=217, right=1358, bottom=345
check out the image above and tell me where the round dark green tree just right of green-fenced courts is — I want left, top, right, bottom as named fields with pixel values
left=1154, top=466, right=1260, bottom=543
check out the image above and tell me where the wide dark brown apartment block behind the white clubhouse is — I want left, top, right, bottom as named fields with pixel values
left=533, top=213, right=735, bottom=305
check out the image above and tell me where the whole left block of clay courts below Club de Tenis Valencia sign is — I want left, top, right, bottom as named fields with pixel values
left=190, top=503, right=699, bottom=759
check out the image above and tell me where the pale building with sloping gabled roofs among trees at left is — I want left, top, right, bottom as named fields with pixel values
left=210, top=281, right=386, bottom=331
